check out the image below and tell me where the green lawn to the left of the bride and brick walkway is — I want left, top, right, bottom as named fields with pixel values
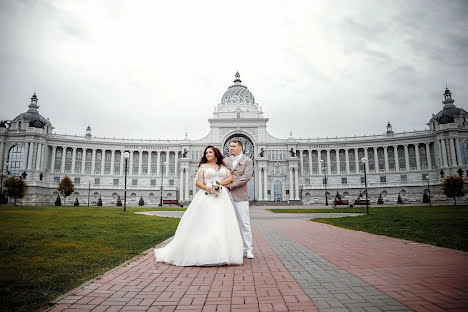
left=0, top=207, right=181, bottom=311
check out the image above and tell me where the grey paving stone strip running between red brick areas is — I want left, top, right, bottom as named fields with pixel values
left=252, top=219, right=411, bottom=312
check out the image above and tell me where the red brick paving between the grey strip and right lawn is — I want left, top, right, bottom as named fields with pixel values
left=270, top=220, right=468, bottom=311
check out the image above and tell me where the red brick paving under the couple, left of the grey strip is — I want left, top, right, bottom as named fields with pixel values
left=50, top=227, right=317, bottom=312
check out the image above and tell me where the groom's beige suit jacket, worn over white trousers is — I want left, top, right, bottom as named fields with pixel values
left=224, top=155, right=253, bottom=201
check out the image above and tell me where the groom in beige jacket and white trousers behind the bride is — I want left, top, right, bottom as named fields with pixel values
left=224, top=140, right=254, bottom=259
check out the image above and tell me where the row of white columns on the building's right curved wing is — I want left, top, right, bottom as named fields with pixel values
left=299, top=143, right=434, bottom=175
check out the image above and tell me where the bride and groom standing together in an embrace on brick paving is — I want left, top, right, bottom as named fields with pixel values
left=154, top=140, right=254, bottom=266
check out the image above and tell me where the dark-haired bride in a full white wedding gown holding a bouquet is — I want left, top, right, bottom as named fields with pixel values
left=154, top=145, right=243, bottom=266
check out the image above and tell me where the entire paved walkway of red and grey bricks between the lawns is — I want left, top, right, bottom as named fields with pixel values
left=50, top=207, right=468, bottom=312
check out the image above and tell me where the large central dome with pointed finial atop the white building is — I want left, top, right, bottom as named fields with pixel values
left=218, top=72, right=258, bottom=112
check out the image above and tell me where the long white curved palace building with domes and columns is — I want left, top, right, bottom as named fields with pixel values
left=0, top=73, right=468, bottom=205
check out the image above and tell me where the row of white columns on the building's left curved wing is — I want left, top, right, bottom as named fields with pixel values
left=51, top=146, right=178, bottom=176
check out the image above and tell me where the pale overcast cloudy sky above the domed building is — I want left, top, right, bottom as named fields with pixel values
left=0, top=0, right=468, bottom=139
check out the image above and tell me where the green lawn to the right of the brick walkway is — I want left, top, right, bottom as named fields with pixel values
left=270, top=206, right=468, bottom=251
